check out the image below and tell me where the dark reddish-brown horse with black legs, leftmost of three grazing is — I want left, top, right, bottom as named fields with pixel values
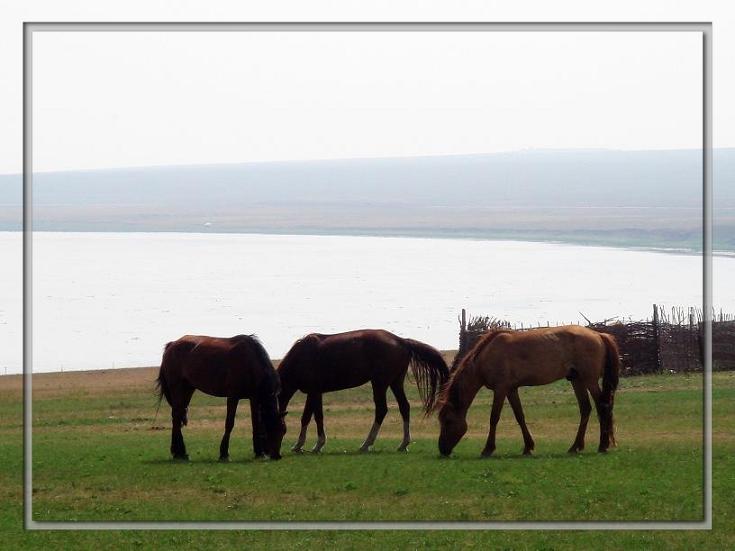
left=157, top=335, right=286, bottom=461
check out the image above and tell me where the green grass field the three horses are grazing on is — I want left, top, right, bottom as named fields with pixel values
left=0, top=369, right=735, bottom=549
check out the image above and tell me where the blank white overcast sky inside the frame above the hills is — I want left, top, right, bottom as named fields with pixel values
left=23, top=32, right=702, bottom=172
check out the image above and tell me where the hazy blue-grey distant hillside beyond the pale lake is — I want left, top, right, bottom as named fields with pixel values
left=0, top=149, right=735, bottom=249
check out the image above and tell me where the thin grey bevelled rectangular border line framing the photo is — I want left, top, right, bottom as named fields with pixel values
left=23, top=22, right=712, bottom=530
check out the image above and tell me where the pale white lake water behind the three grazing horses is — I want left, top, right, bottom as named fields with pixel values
left=0, top=232, right=735, bottom=374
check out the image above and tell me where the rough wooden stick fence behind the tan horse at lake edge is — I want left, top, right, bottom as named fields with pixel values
left=455, top=304, right=735, bottom=375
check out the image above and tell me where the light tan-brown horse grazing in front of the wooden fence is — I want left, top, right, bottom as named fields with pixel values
left=437, top=325, right=620, bottom=457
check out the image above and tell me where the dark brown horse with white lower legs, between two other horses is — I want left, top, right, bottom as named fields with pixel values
left=278, top=329, right=449, bottom=452
